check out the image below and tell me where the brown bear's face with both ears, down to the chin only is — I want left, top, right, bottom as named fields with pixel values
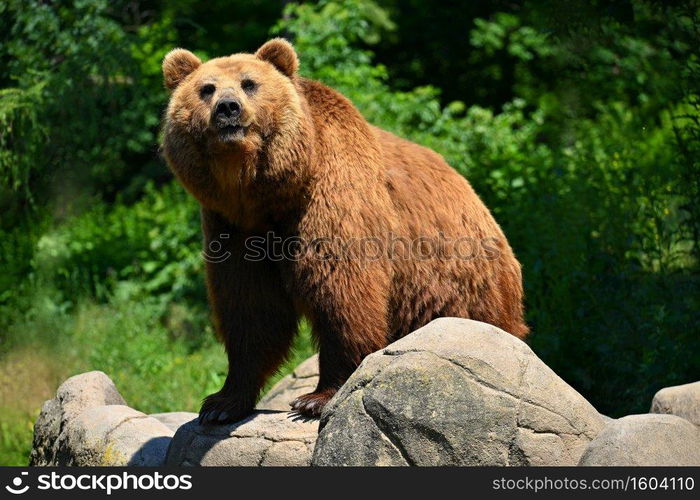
left=163, top=38, right=299, bottom=145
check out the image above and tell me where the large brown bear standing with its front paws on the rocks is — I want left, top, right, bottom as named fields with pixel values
left=163, top=39, right=528, bottom=423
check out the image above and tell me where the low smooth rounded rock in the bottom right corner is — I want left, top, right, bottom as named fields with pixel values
left=579, top=414, right=700, bottom=466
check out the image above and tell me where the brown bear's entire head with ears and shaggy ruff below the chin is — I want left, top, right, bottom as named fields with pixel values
left=163, top=38, right=309, bottom=218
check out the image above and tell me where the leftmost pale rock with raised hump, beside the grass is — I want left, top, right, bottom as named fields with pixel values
left=30, top=372, right=173, bottom=466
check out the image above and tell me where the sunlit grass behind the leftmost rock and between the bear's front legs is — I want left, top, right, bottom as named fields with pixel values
left=0, top=294, right=313, bottom=465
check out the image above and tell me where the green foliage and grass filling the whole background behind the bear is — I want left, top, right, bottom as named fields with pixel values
left=0, top=0, right=700, bottom=463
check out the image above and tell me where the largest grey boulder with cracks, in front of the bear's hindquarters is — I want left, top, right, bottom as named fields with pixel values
left=312, top=318, right=605, bottom=466
